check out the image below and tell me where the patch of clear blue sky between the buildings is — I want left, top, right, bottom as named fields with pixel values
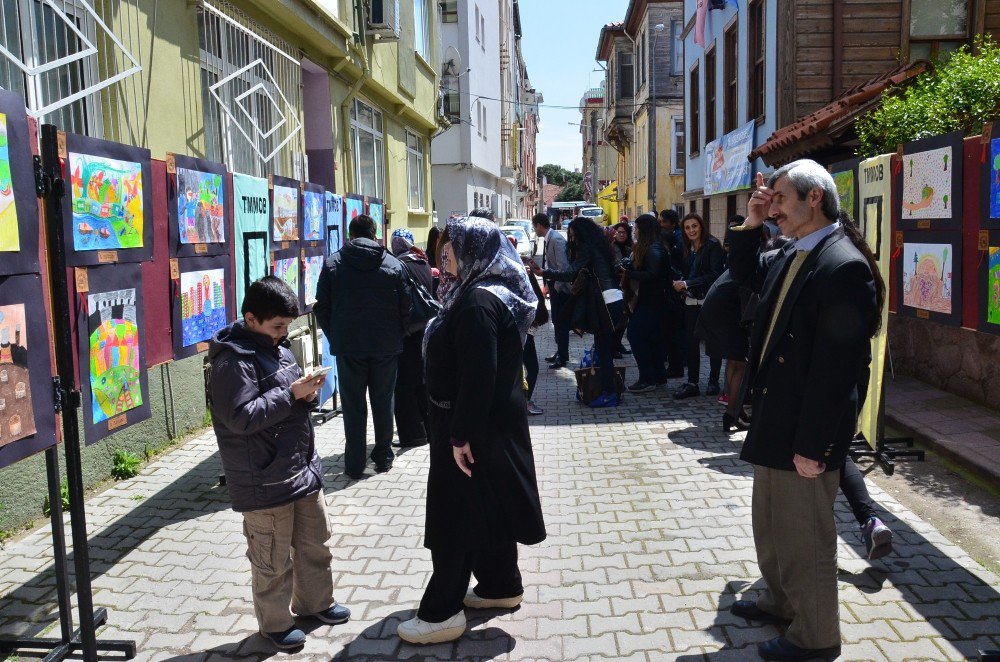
left=518, top=0, right=628, bottom=170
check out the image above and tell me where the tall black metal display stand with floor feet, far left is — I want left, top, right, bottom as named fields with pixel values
left=0, top=124, right=136, bottom=662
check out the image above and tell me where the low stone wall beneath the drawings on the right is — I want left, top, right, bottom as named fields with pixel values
left=889, top=315, right=1000, bottom=410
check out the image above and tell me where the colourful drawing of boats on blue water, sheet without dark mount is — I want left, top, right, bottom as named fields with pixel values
left=69, top=152, right=145, bottom=251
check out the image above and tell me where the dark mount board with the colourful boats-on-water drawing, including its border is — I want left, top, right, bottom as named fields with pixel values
left=60, top=133, right=153, bottom=267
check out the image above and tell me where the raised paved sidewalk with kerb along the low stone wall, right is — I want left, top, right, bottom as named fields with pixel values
left=885, top=376, right=1000, bottom=487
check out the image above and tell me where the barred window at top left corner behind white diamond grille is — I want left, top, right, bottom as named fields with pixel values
left=0, top=0, right=104, bottom=137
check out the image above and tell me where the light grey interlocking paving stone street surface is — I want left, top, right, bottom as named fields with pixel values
left=0, top=330, right=1000, bottom=662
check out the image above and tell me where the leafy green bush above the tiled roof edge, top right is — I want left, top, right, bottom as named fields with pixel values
left=855, top=35, right=1000, bottom=157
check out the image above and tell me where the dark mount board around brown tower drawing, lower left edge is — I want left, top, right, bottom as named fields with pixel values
left=0, top=274, right=57, bottom=468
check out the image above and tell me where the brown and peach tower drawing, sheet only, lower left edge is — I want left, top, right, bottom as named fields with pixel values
left=0, top=303, right=35, bottom=446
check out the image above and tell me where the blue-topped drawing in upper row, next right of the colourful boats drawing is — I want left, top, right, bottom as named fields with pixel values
left=177, top=168, right=226, bottom=244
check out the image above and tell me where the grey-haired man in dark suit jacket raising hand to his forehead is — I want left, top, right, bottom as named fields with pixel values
left=730, top=160, right=878, bottom=660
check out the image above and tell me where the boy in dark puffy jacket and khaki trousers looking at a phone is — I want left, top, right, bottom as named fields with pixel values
left=208, top=276, right=351, bottom=649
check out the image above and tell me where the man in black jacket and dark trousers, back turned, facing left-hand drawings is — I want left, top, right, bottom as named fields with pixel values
left=313, top=214, right=411, bottom=479
